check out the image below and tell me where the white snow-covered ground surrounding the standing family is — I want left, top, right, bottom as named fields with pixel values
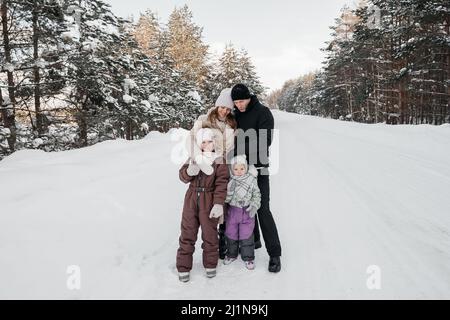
left=0, top=111, right=450, bottom=299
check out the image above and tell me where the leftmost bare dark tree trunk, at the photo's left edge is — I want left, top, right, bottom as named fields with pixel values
left=0, top=0, right=17, bottom=152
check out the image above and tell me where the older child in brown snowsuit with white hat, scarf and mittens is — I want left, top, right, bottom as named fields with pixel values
left=176, top=128, right=230, bottom=282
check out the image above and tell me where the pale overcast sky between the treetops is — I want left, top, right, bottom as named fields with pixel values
left=105, top=0, right=355, bottom=90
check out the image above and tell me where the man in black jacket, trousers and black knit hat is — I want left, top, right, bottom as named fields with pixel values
left=227, top=84, right=281, bottom=272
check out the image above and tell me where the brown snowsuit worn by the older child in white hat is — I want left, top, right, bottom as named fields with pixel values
left=177, top=158, right=230, bottom=272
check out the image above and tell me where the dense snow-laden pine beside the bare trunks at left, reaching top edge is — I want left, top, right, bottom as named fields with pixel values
left=61, top=0, right=123, bottom=146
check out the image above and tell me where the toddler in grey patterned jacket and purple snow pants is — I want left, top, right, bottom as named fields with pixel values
left=223, top=155, right=261, bottom=270
